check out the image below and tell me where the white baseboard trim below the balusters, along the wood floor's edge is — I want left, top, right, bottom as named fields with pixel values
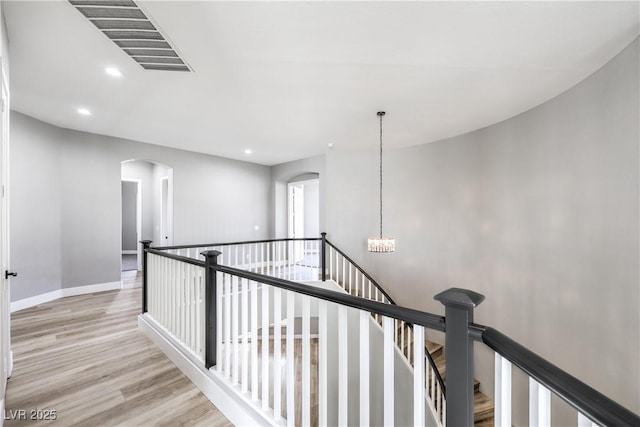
left=138, top=314, right=284, bottom=426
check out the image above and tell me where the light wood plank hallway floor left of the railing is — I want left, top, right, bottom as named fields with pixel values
left=5, top=272, right=231, bottom=427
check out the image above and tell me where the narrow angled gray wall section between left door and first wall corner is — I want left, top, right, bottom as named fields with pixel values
left=9, top=112, right=62, bottom=301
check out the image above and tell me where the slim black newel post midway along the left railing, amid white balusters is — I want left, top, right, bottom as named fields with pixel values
left=200, top=251, right=222, bottom=369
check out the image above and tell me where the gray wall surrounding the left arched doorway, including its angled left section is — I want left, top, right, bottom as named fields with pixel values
left=11, top=112, right=271, bottom=301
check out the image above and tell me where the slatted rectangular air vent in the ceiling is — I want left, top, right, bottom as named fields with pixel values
left=69, top=0, right=193, bottom=71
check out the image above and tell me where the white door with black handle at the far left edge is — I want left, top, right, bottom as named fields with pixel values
left=0, top=63, right=13, bottom=409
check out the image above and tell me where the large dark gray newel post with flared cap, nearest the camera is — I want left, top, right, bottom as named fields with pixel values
left=434, top=288, right=484, bottom=427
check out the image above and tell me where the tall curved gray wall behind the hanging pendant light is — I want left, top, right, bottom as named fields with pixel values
left=322, top=36, right=640, bottom=425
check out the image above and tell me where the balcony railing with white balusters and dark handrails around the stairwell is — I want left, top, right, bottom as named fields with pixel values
left=143, top=235, right=640, bottom=426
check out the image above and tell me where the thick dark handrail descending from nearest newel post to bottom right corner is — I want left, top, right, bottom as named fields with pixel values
left=482, top=325, right=640, bottom=427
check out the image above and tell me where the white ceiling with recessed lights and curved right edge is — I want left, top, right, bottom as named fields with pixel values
left=2, top=0, right=639, bottom=165
